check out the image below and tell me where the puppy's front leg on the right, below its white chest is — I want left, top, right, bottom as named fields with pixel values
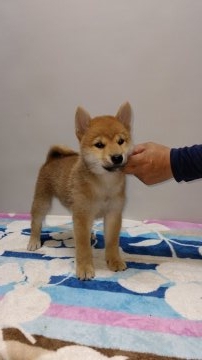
left=104, top=212, right=126, bottom=271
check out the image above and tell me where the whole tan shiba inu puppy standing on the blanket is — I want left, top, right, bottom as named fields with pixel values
left=28, top=103, right=131, bottom=280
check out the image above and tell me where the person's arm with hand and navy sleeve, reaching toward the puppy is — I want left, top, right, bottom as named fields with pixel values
left=125, top=142, right=202, bottom=185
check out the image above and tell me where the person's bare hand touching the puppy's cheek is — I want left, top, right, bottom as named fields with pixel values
left=124, top=142, right=173, bottom=185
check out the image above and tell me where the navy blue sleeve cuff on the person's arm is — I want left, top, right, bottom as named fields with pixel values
left=170, top=145, right=202, bottom=182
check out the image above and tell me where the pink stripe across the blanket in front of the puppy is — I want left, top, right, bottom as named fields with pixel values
left=44, top=304, right=202, bottom=337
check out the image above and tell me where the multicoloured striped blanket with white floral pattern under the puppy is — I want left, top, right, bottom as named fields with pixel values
left=0, top=214, right=202, bottom=360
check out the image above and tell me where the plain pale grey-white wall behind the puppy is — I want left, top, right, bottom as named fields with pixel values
left=0, top=0, right=202, bottom=221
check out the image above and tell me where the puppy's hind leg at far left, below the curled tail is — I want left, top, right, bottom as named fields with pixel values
left=27, top=182, right=52, bottom=251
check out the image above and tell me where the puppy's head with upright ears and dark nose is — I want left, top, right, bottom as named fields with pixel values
left=75, top=102, right=132, bottom=174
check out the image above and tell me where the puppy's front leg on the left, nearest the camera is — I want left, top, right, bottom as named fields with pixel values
left=73, top=212, right=95, bottom=280
